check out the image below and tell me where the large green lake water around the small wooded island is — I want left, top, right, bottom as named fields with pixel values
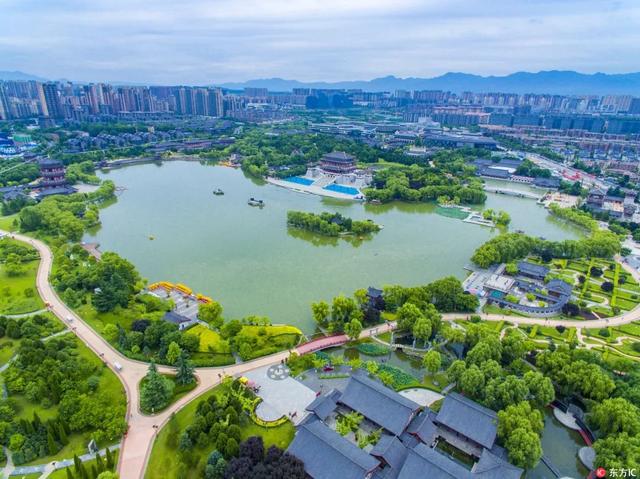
left=85, top=162, right=579, bottom=332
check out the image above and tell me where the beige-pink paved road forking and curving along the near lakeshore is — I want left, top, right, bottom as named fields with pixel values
left=5, top=230, right=640, bottom=479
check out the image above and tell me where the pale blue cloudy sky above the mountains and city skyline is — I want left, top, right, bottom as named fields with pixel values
left=0, top=0, right=640, bottom=84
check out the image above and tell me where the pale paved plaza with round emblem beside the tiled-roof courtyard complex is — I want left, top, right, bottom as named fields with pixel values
left=245, top=364, right=316, bottom=424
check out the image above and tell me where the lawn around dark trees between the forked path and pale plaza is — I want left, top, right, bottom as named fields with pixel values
left=145, top=385, right=295, bottom=479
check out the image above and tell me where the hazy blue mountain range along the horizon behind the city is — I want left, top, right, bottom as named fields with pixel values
left=220, top=70, right=640, bottom=96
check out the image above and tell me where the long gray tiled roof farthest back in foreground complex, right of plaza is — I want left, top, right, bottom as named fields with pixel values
left=340, top=373, right=420, bottom=436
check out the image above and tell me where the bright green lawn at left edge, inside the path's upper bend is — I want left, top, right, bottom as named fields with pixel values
left=0, top=255, right=44, bottom=314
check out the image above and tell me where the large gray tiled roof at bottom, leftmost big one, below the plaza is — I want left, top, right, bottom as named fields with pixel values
left=287, top=421, right=380, bottom=479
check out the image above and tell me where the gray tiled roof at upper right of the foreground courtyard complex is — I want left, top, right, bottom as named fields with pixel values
left=436, top=393, right=498, bottom=449
